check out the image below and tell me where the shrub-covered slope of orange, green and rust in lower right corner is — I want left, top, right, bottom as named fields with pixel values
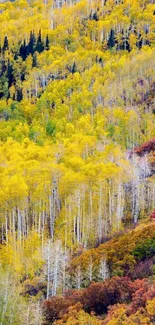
left=43, top=222, right=155, bottom=325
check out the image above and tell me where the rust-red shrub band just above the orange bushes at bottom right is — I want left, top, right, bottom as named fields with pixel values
left=43, top=277, right=155, bottom=325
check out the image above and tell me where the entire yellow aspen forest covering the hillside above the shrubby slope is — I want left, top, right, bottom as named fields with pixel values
left=0, top=1, right=155, bottom=256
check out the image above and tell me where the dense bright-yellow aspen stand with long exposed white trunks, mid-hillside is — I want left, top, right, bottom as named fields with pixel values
left=0, top=120, right=154, bottom=247
